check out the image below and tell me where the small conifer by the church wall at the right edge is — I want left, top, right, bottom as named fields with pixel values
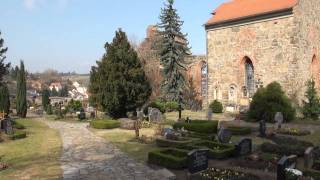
left=302, top=79, right=320, bottom=120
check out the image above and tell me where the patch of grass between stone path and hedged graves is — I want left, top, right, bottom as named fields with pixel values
left=92, top=128, right=157, bottom=162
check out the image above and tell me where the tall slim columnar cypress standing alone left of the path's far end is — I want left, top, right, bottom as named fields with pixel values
left=17, top=61, right=27, bottom=118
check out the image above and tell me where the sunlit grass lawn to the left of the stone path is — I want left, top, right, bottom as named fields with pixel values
left=0, top=119, right=62, bottom=180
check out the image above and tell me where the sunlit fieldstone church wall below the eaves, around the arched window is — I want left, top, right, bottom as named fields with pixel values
left=207, top=15, right=296, bottom=105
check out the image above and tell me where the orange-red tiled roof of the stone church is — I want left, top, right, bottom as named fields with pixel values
left=206, top=0, right=298, bottom=25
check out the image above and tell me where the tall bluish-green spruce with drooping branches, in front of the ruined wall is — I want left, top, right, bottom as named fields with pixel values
left=158, top=0, right=190, bottom=119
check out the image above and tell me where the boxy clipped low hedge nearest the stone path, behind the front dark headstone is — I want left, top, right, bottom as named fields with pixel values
left=148, top=149, right=189, bottom=169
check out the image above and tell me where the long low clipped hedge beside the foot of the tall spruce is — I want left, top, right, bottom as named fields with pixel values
left=173, top=120, right=218, bottom=134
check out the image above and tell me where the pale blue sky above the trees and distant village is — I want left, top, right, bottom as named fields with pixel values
left=0, top=0, right=225, bottom=73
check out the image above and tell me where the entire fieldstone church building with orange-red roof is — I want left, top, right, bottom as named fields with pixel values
left=204, top=0, right=320, bottom=109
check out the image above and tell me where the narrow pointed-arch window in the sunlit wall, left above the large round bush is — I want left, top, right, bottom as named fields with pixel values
left=244, top=57, right=254, bottom=97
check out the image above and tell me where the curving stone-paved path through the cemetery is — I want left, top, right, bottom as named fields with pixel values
left=41, top=120, right=165, bottom=180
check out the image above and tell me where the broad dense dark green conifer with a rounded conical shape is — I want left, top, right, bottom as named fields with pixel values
left=90, top=30, right=151, bottom=118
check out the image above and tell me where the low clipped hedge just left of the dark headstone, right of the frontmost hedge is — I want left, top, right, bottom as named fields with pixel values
left=194, top=141, right=235, bottom=159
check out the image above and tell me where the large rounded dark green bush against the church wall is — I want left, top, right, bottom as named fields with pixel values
left=247, top=82, right=296, bottom=123
